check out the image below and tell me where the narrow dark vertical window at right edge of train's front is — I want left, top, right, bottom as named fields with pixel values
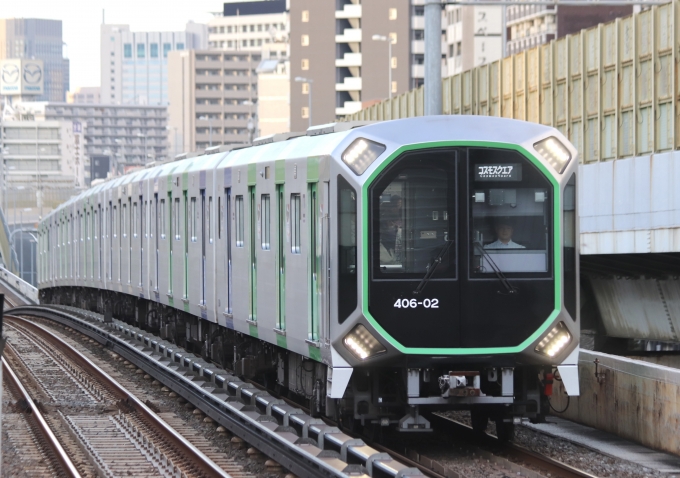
left=562, top=173, right=578, bottom=320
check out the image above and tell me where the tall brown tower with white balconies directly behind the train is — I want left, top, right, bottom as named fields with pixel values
left=290, top=0, right=414, bottom=131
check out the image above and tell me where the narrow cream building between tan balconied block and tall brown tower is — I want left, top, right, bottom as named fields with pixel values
left=257, top=58, right=290, bottom=136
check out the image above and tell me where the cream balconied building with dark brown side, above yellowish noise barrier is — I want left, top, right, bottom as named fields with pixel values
left=506, top=5, right=633, bottom=55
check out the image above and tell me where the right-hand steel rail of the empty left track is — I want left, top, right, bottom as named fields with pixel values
left=5, top=315, right=231, bottom=478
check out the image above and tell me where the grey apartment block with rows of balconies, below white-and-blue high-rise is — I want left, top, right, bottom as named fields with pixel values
left=15, top=102, right=168, bottom=181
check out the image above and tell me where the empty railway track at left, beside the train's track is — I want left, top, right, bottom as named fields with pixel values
left=5, top=315, right=240, bottom=478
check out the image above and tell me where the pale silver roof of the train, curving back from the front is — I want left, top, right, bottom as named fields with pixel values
left=39, top=115, right=564, bottom=224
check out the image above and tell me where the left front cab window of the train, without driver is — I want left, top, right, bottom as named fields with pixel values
left=371, top=150, right=456, bottom=279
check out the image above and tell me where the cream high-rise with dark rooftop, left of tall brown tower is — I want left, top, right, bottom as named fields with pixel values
left=208, top=0, right=289, bottom=58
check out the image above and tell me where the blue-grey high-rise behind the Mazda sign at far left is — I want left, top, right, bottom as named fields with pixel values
left=0, top=18, right=69, bottom=101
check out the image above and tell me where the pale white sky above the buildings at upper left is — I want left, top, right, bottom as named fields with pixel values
left=0, top=0, right=224, bottom=90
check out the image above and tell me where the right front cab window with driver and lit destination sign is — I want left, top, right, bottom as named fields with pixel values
left=469, top=149, right=552, bottom=277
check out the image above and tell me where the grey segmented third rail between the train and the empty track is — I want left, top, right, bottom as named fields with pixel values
left=6, top=305, right=426, bottom=478
